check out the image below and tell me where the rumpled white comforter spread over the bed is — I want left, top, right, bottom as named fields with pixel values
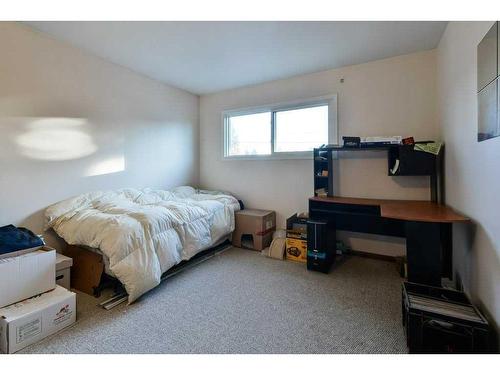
left=45, top=186, right=239, bottom=302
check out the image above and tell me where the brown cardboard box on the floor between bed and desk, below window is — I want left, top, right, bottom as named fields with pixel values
left=232, top=209, right=276, bottom=251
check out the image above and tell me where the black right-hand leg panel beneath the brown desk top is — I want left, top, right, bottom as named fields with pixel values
left=406, top=221, right=442, bottom=286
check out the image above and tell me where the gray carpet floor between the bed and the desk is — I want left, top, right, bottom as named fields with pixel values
left=22, top=248, right=406, bottom=353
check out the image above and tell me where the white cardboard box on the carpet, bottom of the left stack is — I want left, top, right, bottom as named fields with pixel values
left=0, top=286, right=76, bottom=353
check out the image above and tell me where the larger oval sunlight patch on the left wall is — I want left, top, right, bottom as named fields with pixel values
left=16, top=117, right=97, bottom=161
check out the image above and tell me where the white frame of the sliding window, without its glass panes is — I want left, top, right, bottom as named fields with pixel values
left=222, top=94, right=338, bottom=160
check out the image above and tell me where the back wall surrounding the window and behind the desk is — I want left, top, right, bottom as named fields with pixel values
left=200, top=50, right=438, bottom=255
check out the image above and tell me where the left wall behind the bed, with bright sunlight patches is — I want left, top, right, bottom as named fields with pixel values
left=0, top=22, right=199, bottom=250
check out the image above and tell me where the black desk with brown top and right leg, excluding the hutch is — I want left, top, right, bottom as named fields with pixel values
left=309, top=197, right=469, bottom=286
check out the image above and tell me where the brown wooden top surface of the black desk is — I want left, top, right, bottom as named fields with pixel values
left=309, top=197, right=469, bottom=223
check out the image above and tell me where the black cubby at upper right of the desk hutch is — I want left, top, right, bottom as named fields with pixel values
left=387, top=146, right=439, bottom=176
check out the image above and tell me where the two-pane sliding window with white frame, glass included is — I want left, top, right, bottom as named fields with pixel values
left=224, top=96, right=337, bottom=159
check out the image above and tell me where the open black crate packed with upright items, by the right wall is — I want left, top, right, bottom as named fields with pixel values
left=402, top=282, right=492, bottom=353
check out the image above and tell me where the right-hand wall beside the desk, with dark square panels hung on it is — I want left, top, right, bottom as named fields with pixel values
left=438, top=22, right=500, bottom=336
